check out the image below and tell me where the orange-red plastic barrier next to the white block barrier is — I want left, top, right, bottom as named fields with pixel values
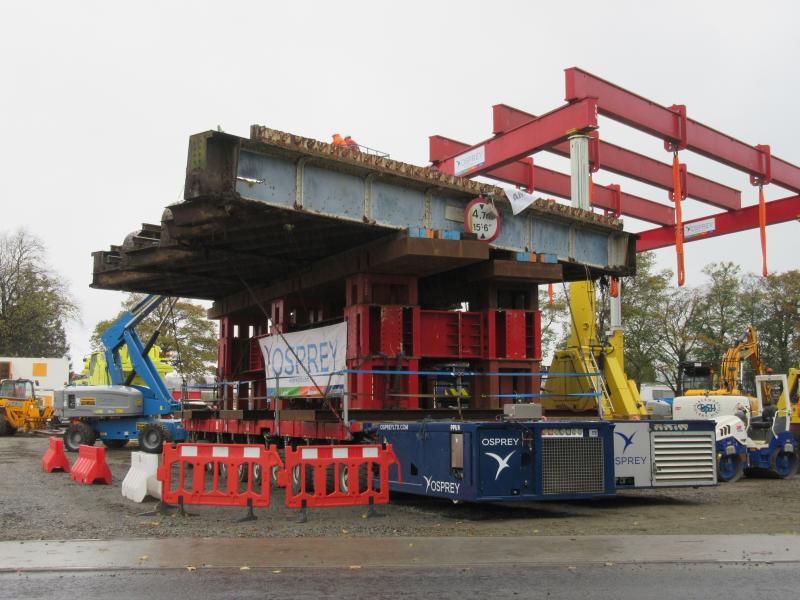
left=158, top=444, right=283, bottom=518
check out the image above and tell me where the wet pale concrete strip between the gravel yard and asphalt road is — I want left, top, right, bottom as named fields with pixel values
left=0, top=535, right=800, bottom=572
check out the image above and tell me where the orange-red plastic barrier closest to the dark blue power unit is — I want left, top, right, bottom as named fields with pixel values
left=280, top=444, right=400, bottom=519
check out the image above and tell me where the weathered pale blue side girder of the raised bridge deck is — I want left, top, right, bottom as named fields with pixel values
left=186, top=131, right=634, bottom=271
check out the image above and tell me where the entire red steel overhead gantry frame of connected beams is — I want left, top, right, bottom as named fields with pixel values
left=430, top=68, right=800, bottom=251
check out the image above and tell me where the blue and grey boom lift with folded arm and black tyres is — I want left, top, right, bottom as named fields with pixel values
left=55, top=295, right=186, bottom=453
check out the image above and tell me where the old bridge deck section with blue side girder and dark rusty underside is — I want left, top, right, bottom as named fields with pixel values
left=92, top=126, right=635, bottom=310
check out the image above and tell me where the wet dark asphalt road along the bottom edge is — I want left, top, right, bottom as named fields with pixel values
left=0, top=563, right=800, bottom=600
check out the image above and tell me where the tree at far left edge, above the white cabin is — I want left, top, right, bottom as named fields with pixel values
left=0, top=229, right=78, bottom=357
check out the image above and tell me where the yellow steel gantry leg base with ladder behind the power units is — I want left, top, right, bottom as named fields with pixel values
left=542, top=281, right=648, bottom=420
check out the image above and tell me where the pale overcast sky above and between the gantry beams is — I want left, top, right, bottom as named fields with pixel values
left=0, top=0, right=800, bottom=367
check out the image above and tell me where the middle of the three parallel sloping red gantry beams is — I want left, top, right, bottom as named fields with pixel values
left=492, top=104, right=742, bottom=210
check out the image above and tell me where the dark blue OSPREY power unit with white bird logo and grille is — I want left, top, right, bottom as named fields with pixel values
left=365, top=421, right=615, bottom=502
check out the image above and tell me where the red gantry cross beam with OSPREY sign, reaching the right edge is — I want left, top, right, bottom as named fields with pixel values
left=636, top=196, right=800, bottom=252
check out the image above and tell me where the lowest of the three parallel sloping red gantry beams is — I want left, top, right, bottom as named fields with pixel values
left=430, top=135, right=675, bottom=225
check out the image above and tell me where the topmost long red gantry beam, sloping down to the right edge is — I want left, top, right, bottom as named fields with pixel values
left=565, top=67, right=800, bottom=193
